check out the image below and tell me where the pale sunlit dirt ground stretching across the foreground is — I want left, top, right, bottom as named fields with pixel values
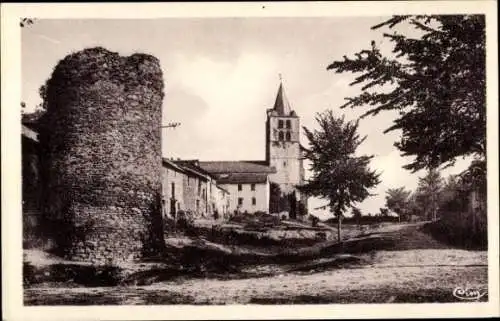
left=25, top=249, right=487, bottom=305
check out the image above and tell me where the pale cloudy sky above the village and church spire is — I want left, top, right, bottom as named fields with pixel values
left=22, top=17, right=468, bottom=218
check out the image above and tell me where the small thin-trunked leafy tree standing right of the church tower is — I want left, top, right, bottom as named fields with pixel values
left=299, top=110, right=380, bottom=241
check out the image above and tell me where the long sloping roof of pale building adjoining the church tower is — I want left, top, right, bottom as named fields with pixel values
left=199, top=161, right=276, bottom=174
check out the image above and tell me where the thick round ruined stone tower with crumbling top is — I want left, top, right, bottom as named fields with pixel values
left=40, top=47, right=164, bottom=264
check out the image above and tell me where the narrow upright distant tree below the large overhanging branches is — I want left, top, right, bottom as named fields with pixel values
left=416, top=169, right=443, bottom=220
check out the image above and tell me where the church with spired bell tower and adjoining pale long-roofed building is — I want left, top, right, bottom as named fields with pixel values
left=199, top=83, right=307, bottom=217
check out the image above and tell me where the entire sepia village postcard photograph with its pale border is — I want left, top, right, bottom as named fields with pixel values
left=2, top=1, right=498, bottom=318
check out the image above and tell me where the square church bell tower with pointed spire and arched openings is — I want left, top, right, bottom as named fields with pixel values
left=266, top=83, right=307, bottom=215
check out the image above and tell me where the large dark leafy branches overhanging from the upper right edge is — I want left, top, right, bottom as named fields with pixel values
left=327, top=15, right=486, bottom=172
